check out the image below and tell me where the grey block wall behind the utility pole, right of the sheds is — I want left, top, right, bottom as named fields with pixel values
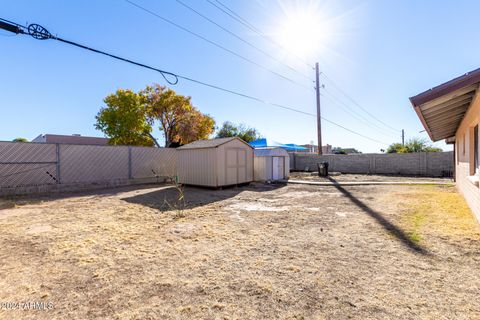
left=290, top=151, right=454, bottom=177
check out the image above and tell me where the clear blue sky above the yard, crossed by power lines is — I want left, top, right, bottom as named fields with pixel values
left=0, top=0, right=480, bottom=152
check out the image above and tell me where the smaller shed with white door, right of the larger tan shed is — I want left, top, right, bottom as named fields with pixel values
left=253, top=148, right=290, bottom=181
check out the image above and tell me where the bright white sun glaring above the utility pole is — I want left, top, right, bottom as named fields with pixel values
left=277, top=10, right=327, bottom=58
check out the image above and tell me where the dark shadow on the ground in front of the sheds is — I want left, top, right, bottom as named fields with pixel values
left=122, top=183, right=285, bottom=211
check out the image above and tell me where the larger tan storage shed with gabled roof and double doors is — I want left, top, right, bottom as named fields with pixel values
left=177, top=138, right=253, bottom=187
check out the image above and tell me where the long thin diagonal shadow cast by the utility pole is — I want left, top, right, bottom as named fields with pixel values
left=327, top=177, right=431, bottom=255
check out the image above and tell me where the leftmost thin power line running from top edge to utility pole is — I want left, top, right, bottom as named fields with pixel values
left=125, top=0, right=312, bottom=90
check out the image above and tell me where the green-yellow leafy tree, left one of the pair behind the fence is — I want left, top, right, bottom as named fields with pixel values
left=95, top=89, right=155, bottom=146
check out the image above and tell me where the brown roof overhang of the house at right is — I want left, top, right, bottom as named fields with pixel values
left=410, top=68, right=480, bottom=141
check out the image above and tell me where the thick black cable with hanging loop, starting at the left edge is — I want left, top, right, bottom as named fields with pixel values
left=0, top=18, right=388, bottom=145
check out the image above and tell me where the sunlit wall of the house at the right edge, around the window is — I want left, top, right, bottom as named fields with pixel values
left=455, top=95, right=480, bottom=222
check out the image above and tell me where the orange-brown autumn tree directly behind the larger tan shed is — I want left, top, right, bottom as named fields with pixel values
left=141, top=84, right=215, bottom=147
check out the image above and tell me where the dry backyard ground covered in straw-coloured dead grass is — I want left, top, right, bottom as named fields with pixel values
left=0, top=184, right=480, bottom=319
